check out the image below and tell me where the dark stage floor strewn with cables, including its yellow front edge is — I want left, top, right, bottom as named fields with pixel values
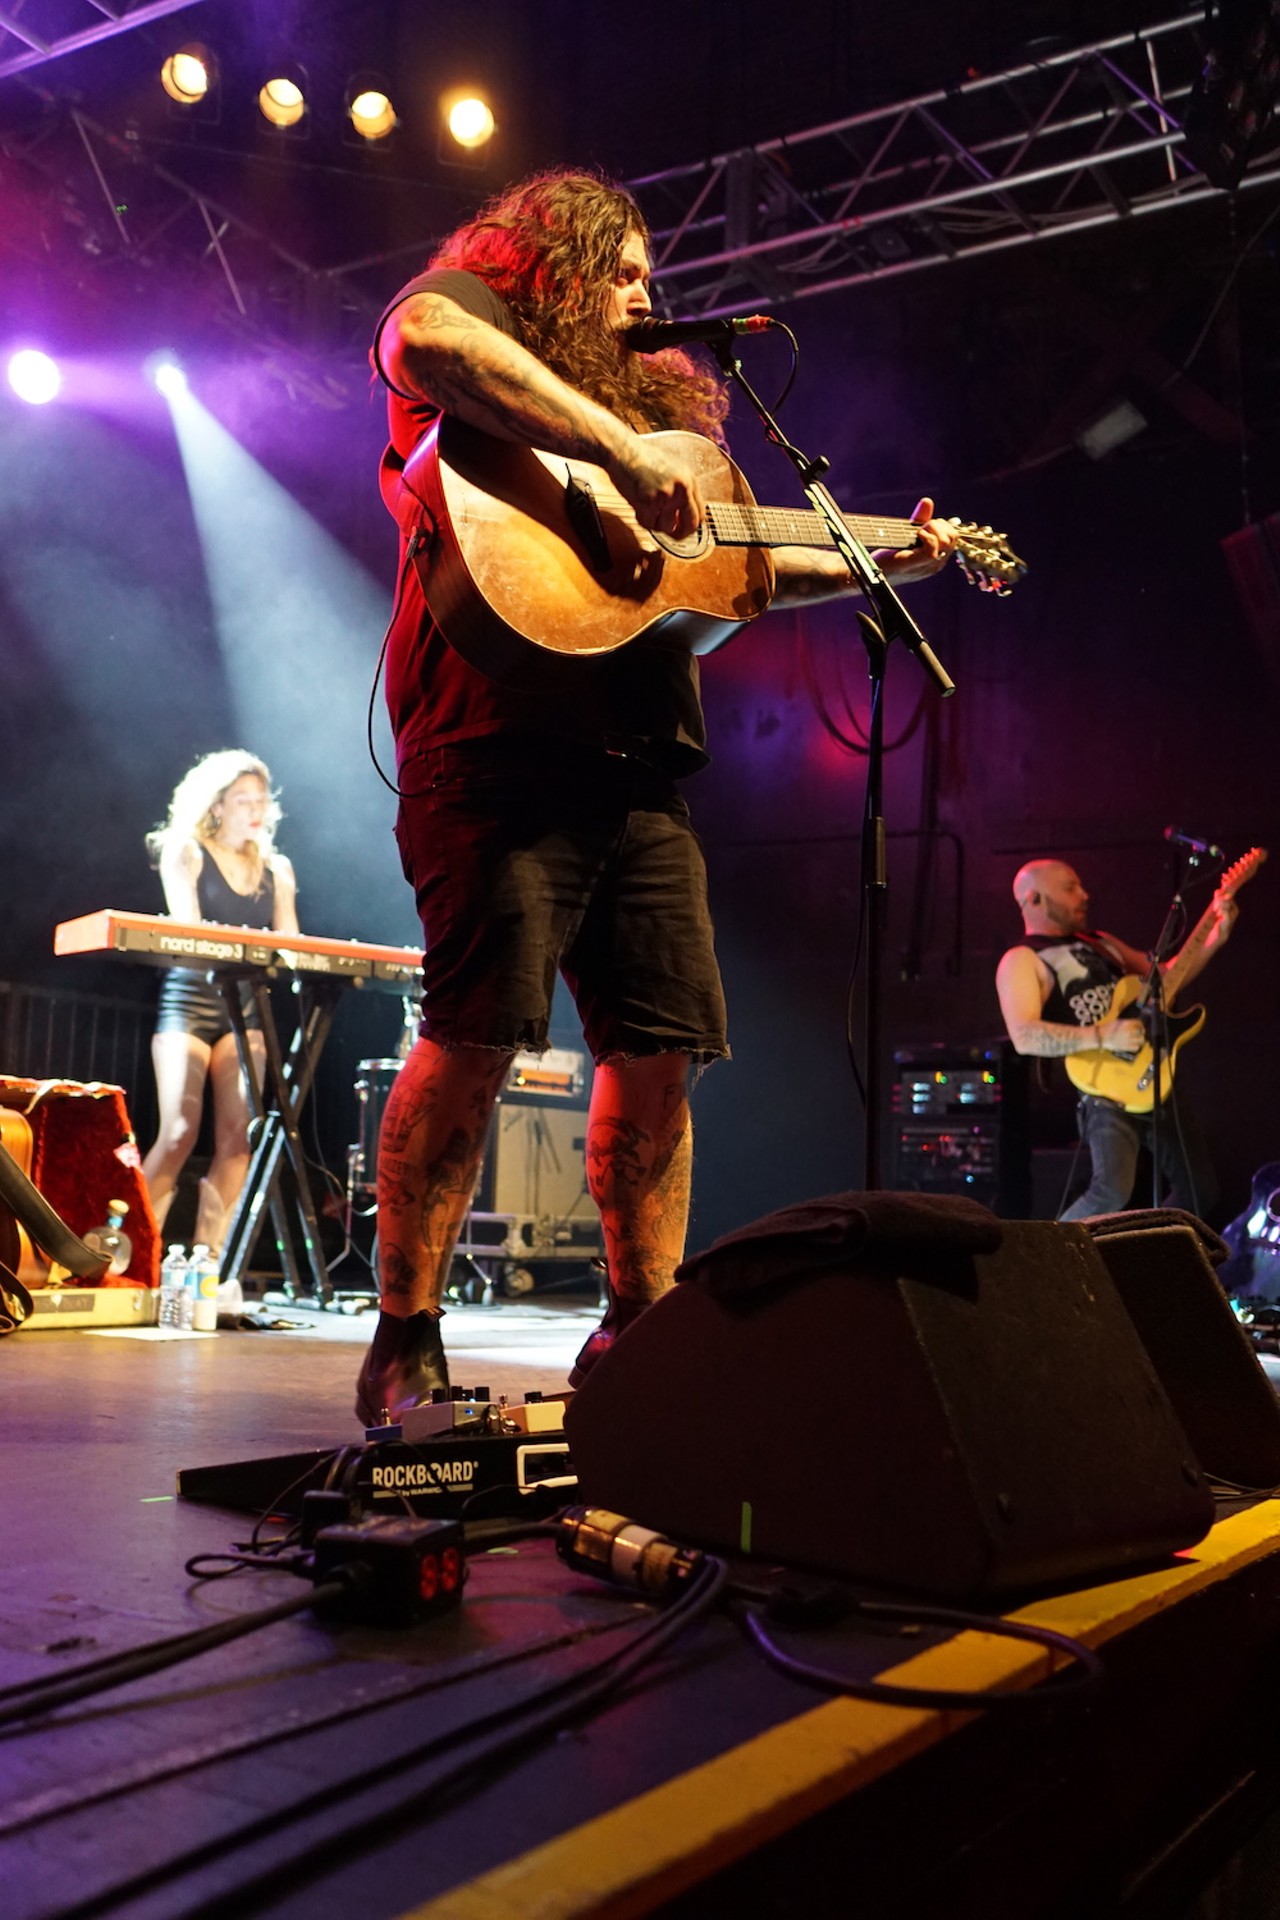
left=0, top=1304, right=1280, bottom=1920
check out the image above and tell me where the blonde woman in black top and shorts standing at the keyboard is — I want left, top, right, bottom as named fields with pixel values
left=142, top=747, right=297, bottom=1252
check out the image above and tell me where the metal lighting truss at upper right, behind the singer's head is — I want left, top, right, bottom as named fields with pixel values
left=629, top=10, right=1280, bottom=315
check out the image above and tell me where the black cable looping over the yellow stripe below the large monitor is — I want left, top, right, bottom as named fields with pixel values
left=741, top=1597, right=1105, bottom=1713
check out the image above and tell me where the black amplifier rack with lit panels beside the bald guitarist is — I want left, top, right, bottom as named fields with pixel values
left=892, top=1041, right=1031, bottom=1219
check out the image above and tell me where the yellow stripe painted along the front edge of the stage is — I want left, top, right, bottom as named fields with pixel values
left=399, top=1500, right=1280, bottom=1920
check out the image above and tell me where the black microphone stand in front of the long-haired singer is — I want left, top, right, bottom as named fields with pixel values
left=712, top=340, right=956, bottom=1192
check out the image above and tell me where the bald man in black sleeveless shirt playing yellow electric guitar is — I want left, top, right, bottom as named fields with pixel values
left=996, top=849, right=1243, bottom=1219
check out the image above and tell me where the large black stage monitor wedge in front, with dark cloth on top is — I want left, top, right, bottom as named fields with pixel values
left=564, top=1221, right=1213, bottom=1597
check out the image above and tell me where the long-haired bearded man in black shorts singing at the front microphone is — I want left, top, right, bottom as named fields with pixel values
left=357, top=173, right=954, bottom=1421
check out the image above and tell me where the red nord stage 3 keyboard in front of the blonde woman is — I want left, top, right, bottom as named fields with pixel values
left=54, top=906, right=422, bottom=993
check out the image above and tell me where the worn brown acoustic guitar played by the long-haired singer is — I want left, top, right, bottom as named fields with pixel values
left=399, top=415, right=1027, bottom=680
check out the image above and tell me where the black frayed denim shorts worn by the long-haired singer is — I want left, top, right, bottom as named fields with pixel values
left=395, top=739, right=729, bottom=1062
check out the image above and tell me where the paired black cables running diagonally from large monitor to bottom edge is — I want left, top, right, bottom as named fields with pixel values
left=59, top=1557, right=727, bottom=1920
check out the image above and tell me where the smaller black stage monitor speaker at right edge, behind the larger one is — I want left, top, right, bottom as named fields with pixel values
left=1094, top=1227, right=1280, bottom=1490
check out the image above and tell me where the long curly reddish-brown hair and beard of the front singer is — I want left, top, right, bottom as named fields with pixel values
left=430, top=171, right=729, bottom=444
